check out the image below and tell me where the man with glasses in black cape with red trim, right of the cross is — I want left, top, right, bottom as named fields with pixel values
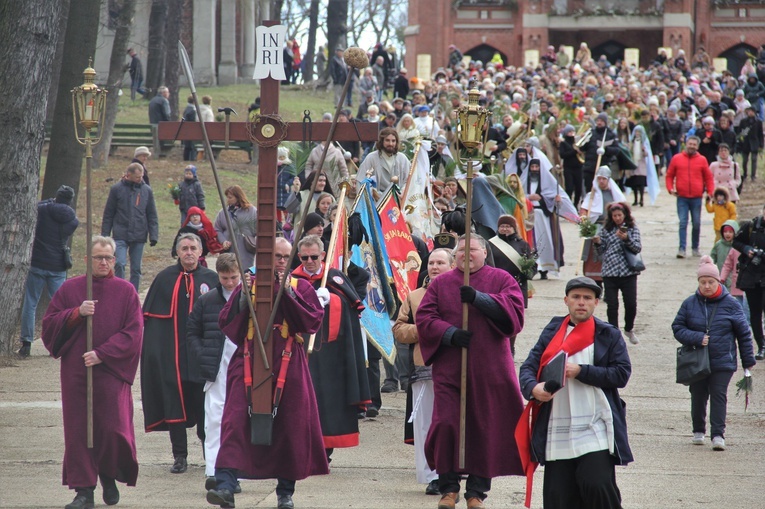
left=292, top=235, right=371, bottom=461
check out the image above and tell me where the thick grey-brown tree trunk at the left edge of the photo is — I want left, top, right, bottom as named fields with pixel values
left=0, top=0, right=63, bottom=357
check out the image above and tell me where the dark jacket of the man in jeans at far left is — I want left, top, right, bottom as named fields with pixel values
left=32, top=198, right=79, bottom=272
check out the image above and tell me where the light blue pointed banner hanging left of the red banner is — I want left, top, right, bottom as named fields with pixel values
left=351, top=180, right=396, bottom=363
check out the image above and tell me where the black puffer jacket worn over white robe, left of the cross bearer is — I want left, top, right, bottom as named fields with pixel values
left=186, top=284, right=226, bottom=382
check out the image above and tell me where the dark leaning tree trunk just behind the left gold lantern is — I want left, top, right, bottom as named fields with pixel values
left=41, top=0, right=104, bottom=204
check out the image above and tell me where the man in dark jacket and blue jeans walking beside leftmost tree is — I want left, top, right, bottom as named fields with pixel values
left=19, top=186, right=79, bottom=357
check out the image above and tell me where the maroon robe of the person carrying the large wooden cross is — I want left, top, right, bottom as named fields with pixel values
left=215, top=280, right=329, bottom=481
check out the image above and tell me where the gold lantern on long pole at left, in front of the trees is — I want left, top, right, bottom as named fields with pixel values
left=72, top=58, right=106, bottom=448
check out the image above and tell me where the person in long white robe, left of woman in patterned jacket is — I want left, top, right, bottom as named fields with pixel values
left=521, top=159, right=577, bottom=279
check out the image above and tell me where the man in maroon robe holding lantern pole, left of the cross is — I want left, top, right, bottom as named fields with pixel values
left=42, top=237, right=143, bottom=509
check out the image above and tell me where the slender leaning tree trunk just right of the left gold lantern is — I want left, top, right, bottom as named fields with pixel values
left=93, top=0, right=135, bottom=168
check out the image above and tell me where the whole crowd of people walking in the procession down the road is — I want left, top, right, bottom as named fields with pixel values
left=19, top=43, right=765, bottom=509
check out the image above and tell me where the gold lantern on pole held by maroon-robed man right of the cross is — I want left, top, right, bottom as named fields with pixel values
left=450, top=85, right=489, bottom=469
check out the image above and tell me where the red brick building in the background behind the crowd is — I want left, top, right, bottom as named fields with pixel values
left=405, top=0, right=765, bottom=75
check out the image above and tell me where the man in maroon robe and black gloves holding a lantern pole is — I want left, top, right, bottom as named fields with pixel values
left=416, top=234, right=523, bottom=509
